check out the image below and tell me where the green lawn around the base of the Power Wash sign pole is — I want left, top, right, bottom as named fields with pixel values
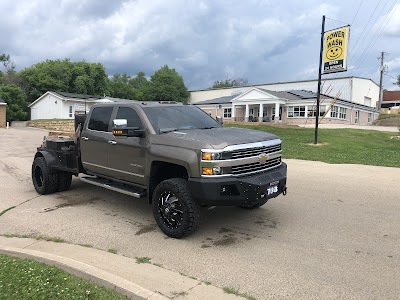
left=225, top=124, right=400, bottom=167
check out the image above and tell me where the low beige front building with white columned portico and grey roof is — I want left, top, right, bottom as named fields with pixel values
left=194, top=87, right=378, bottom=125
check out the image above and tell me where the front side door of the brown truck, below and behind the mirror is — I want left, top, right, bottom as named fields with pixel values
left=107, top=106, right=147, bottom=185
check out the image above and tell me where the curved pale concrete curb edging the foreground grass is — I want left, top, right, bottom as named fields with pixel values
left=0, top=245, right=169, bottom=300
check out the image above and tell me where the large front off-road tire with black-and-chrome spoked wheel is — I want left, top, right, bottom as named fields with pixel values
left=152, top=178, right=200, bottom=239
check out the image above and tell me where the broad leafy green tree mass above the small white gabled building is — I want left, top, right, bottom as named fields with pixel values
left=20, top=59, right=108, bottom=102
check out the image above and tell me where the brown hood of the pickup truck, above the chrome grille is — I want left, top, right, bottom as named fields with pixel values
left=154, top=127, right=278, bottom=150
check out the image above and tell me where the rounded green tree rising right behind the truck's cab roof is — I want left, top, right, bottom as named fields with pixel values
left=144, top=65, right=190, bottom=102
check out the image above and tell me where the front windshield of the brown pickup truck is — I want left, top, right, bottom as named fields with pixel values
left=143, top=105, right=221, bottom=133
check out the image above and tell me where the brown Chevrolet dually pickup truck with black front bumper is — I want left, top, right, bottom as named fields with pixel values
left=32, top=100, right=287, bottom=238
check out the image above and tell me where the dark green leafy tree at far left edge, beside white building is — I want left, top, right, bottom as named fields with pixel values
left=0, top=84, right=28, bottom=122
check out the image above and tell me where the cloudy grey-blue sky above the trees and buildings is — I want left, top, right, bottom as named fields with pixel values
left=0, top=0, right=400, bottom=90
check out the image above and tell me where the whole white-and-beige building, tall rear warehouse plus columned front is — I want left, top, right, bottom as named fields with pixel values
left=190, top=77, right=379, bottom=125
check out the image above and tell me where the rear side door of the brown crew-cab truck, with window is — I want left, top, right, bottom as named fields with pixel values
left=81, top=106, right=113, bottom=176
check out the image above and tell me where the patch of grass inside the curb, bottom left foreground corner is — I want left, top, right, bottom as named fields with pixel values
left=0, top=255, right=128, bottom=300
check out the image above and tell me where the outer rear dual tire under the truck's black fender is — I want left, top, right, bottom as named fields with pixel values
left=32, top=157, right=59, bottom=195
